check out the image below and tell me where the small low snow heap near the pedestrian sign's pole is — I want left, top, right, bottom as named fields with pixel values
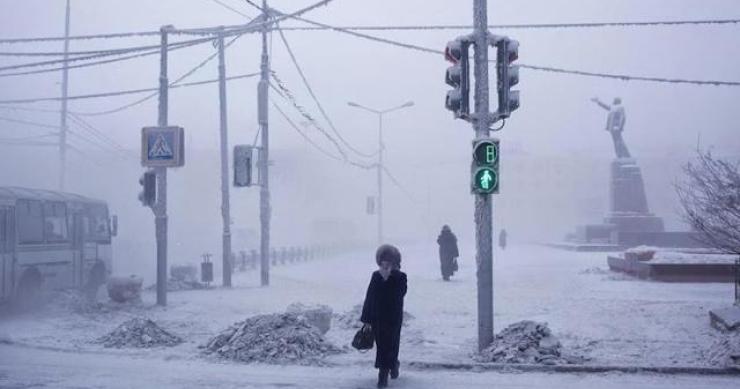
left=97, top=318, right=182, bottom=348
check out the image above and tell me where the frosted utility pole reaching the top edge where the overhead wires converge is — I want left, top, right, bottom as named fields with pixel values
left=257, top=0, right=272, bottom=286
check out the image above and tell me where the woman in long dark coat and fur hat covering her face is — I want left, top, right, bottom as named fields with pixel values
left=360, top=244, right=407, bottom=388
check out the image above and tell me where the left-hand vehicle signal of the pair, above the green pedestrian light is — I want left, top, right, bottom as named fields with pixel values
left=445, top=38, right=470, bottom=119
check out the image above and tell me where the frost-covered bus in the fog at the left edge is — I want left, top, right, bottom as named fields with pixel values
left=0, top=187, right=118, bottom=304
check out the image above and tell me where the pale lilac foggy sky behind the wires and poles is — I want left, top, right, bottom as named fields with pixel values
left=0, top=0, right=740, bottom=278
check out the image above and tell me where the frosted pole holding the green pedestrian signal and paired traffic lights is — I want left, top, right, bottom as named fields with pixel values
left=473, top=0, right=493, bottom=351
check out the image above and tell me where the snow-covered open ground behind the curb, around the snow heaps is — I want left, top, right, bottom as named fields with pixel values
left=0, top=244, right=732, bottom=386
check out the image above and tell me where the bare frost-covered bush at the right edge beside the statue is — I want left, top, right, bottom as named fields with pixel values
left=676, top=150, right=740, bottom=255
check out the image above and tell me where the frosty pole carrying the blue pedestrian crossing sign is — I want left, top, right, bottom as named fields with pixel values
left=154, top=26, right=172, bottom=306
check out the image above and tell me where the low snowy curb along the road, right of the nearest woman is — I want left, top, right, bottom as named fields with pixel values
left=404, top=361, right=740, bottom=376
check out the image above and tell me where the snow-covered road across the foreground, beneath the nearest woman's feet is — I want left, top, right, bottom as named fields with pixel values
left=0, top=345, right=740, bottom=389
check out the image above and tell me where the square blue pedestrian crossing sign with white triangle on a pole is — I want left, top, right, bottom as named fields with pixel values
left=141, top=126, right=185, bottom=167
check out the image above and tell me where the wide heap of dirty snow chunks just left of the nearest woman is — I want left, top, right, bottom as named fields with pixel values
left=205, top=313, right=342, bottom=365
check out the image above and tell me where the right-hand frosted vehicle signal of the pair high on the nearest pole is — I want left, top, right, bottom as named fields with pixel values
left=496, top=37, right=519, bottom=119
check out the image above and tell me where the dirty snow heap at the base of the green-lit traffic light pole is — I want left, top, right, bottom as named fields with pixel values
left=476, top=320, right=575, bottom=365
